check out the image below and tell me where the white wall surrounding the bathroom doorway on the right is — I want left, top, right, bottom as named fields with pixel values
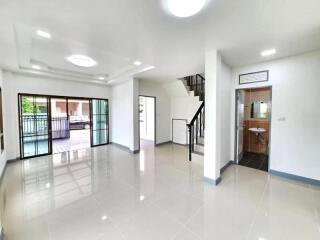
left=230, top=51, right=320, bottom=180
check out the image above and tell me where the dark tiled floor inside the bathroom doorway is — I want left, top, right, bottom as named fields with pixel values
left=239, top=152, right=269, bottom=172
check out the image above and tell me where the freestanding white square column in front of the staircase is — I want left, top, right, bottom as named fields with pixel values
left=204, top=50, right=221, bottom=185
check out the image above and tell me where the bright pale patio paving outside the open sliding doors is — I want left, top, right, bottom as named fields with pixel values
left=52, top=129, right=90, bottom=153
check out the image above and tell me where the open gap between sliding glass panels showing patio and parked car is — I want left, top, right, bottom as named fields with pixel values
left=51, top=98, right=90, bottom=153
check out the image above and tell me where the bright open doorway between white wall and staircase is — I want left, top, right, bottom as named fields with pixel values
left=139, top=96, right=156, bottom=146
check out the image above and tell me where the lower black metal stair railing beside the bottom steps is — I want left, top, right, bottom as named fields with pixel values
left=187, top=102, right=205, bottom=161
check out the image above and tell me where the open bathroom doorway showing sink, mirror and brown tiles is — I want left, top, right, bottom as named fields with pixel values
left=235, top=87, right=272, bottom=172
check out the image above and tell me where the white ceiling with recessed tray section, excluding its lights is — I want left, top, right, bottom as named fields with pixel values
left=0, top=0, right=320, bottom=83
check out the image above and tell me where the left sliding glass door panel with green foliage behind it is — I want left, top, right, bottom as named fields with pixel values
left=19, top=94, right=51, bottom=158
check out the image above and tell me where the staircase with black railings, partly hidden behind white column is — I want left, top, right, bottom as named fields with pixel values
left=182, top=74, right=205, bottom=161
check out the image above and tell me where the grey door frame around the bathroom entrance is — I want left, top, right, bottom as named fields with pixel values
left=234, top=85, right=273, bottom=172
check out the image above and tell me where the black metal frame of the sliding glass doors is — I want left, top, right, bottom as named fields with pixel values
left=18, top=92, right=110, bottom=160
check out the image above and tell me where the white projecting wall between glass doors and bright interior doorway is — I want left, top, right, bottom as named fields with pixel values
left=111, top=78, right=139, bottom=151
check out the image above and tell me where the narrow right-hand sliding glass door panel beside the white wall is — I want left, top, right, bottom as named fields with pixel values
left=90, top=99, right=109, bottom=146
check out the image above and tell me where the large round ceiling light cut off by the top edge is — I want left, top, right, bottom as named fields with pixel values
left=168, top=0, right=206, bottom=17
